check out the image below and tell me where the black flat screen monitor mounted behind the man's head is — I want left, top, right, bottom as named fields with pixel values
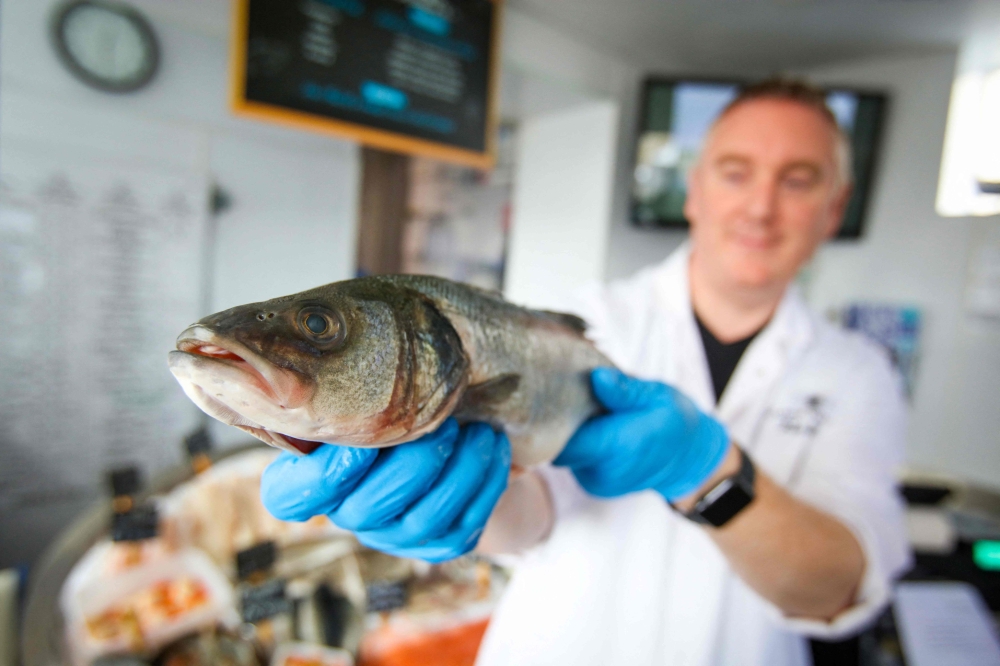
left=632, top=78, right=887, bottom=238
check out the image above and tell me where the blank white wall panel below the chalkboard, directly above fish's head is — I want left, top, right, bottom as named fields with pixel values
left=210, top=132, right=360, bottom=311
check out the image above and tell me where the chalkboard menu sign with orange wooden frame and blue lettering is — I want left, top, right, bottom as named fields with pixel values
left=232, top=0, right=502, bottom=168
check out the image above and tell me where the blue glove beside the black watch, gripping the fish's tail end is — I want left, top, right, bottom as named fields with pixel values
left=553, top=368, right=729, bottom=501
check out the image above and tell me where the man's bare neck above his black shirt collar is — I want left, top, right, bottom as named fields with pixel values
left=688, top=249, right=785, bottom=343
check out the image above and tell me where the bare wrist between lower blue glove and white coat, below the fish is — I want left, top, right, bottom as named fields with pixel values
left=476, top=471, right=554, bottom=555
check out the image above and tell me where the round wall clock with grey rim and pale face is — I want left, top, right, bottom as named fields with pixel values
left=55, top=0, right=159, bottom=92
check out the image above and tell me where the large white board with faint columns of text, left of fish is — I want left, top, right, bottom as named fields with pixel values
left=0, top=139, right=207, bottom=561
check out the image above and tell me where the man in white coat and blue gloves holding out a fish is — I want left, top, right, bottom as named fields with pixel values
left=263, top=80, right=908, bottom=666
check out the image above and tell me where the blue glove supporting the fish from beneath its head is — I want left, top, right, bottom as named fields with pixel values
left=261, top=419, right=510, bottom=562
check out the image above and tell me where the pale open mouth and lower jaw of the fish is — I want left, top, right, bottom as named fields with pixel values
left=170, top=324, right=322, bottom=453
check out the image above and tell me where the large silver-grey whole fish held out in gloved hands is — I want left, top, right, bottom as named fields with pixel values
left=169, top=275, right=613, bottom=467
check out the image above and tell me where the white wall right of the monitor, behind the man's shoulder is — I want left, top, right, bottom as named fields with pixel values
left=809, top=53, right=1000, bottom=487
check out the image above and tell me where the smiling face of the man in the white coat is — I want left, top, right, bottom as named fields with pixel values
left=684, top=99, right=850, bottom=287
